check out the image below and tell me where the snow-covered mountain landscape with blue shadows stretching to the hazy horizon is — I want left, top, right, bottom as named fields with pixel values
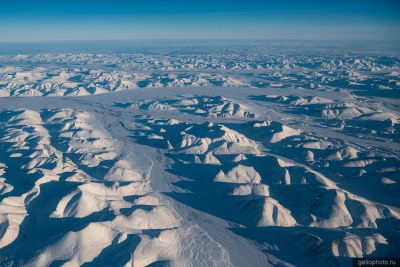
left=0, top=49, right=400, bottom=267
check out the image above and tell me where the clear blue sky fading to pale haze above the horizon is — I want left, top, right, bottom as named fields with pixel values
left=0, top=0, right=400, bottom=42
